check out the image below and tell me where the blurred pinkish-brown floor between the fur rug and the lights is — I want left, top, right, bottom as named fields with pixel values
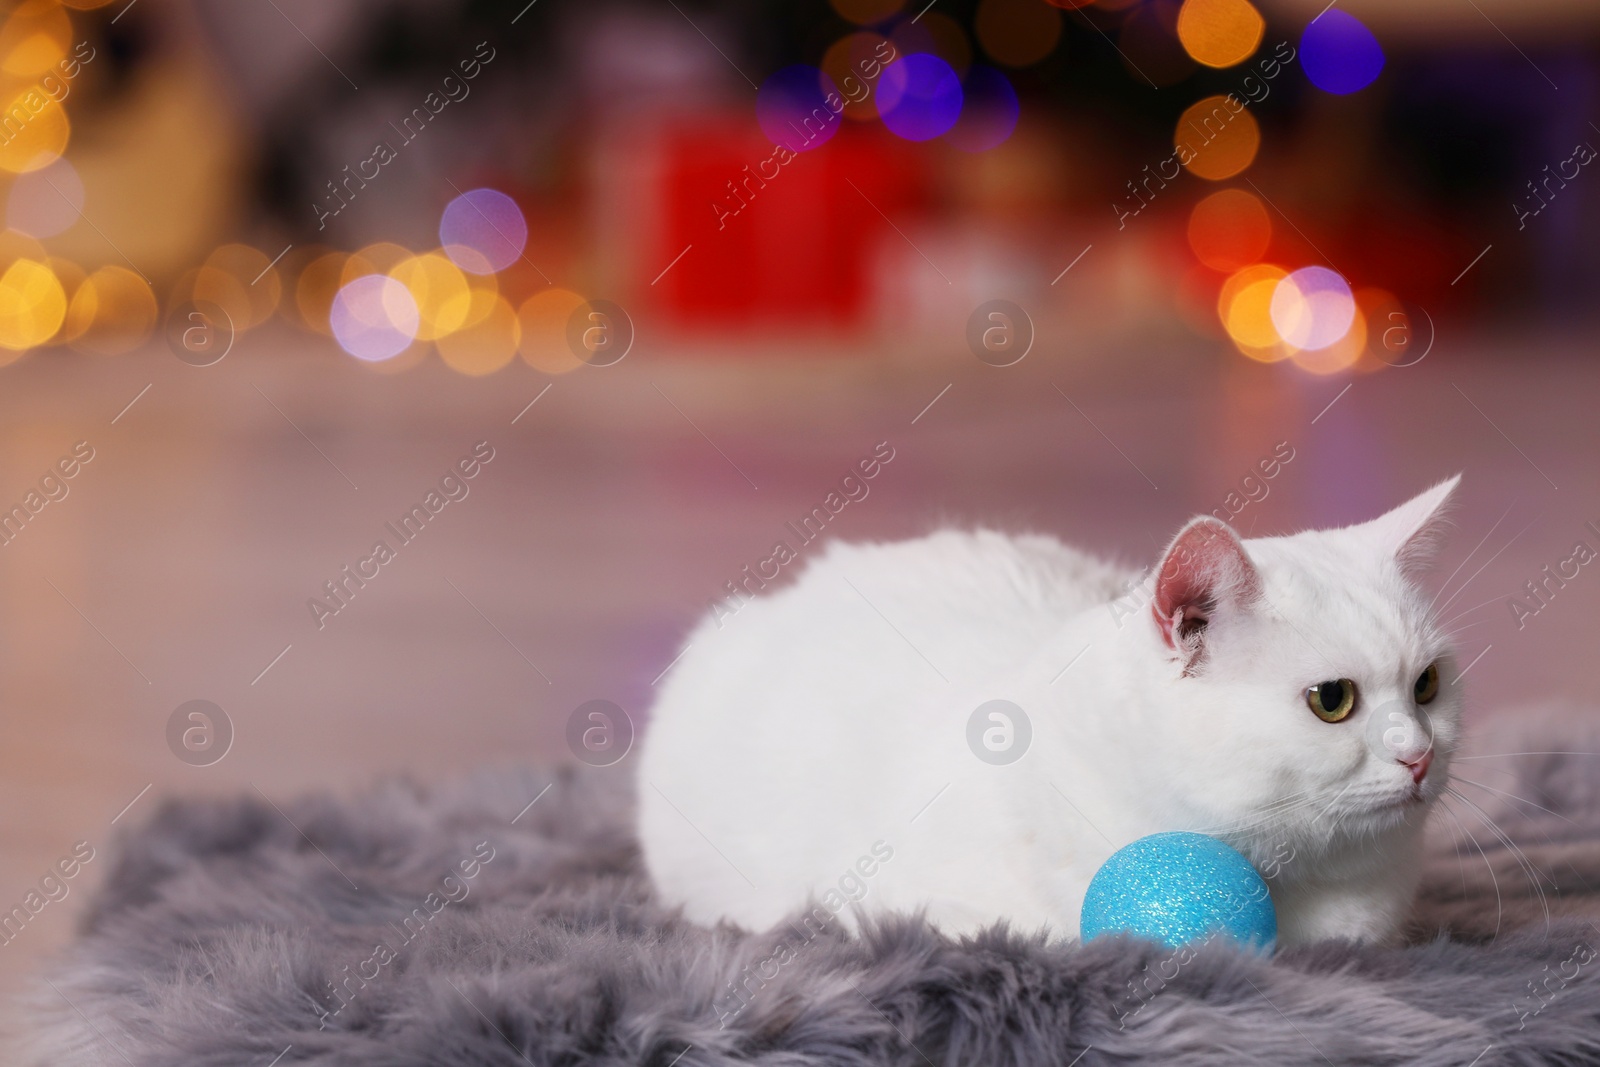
left=0, top=323, right=1600, bottom=992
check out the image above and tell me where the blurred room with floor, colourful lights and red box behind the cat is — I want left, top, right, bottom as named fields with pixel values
left=0, top=0, right=1600, bottom=990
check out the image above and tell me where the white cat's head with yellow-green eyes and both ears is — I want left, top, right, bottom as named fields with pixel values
left=1147, top=475, right=1461, bottom=870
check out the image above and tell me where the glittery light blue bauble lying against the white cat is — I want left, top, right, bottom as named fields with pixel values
left=1078, top=832, right=1278, bottom=952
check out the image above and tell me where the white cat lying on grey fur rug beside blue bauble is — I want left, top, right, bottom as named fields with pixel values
left=638, top=475, right=1461, bottom=944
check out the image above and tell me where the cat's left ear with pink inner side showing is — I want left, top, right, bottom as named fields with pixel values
left=1150, top=515, right=1261, bottom=667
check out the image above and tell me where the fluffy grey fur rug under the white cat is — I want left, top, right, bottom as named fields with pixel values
left=12, top=703, right=1600, bottom=1067
